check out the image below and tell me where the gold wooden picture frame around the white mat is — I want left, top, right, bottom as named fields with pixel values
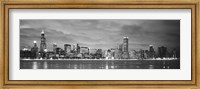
left=0, top=0, right=200, bottom=89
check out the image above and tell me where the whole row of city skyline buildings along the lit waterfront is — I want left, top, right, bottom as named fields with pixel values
left=20, top=30, right=179, bottom=60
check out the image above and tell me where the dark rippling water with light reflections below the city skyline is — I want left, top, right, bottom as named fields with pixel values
left=20, top=59, right=180, bottom=69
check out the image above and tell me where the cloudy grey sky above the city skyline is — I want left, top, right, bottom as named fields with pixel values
left=20, top=19, right=180, bottom=51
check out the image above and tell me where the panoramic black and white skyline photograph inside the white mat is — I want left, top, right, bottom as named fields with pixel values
left=19, top=19, right=181, bottom=69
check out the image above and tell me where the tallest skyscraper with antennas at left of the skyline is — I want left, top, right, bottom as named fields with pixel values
left=40, top=31, right=47, bottom=52
